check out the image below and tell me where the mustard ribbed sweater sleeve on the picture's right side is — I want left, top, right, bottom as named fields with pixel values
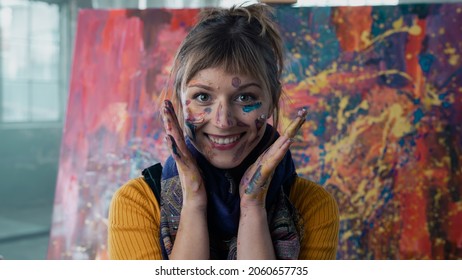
left=289, top=177, right=339, bottom=260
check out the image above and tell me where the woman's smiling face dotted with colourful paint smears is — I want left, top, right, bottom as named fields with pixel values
left=181, top=68, right=272, bottom=169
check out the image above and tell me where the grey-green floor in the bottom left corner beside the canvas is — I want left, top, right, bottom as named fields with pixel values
left=0, top=205, right=52, bottom=260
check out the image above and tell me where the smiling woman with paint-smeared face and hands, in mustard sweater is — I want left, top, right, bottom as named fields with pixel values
left=108, top=4, right=339, bottom=259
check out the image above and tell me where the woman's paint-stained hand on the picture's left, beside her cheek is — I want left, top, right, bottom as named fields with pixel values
left=161, top=100, right=207, bottom=211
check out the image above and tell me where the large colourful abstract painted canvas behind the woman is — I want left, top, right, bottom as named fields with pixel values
left=48, top=4, right=462, bottom=259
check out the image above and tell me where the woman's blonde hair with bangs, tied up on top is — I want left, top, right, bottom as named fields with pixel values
left=171, top=3, right=284, bottom=127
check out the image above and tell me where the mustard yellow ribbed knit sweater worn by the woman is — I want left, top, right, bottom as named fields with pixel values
left=108, top=177, right=339, bottom=260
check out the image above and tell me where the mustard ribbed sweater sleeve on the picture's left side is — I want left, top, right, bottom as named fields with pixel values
left=108, top=178, right=162, bottom=260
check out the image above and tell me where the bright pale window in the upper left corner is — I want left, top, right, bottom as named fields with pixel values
left=0, top=0, right=64, bottom=124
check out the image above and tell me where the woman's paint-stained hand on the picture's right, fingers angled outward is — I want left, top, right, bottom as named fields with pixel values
left=239, top=109, right=307, bottom=208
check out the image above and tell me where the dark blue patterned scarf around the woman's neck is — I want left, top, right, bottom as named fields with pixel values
left=160, top=125, right=300, bottom=259
